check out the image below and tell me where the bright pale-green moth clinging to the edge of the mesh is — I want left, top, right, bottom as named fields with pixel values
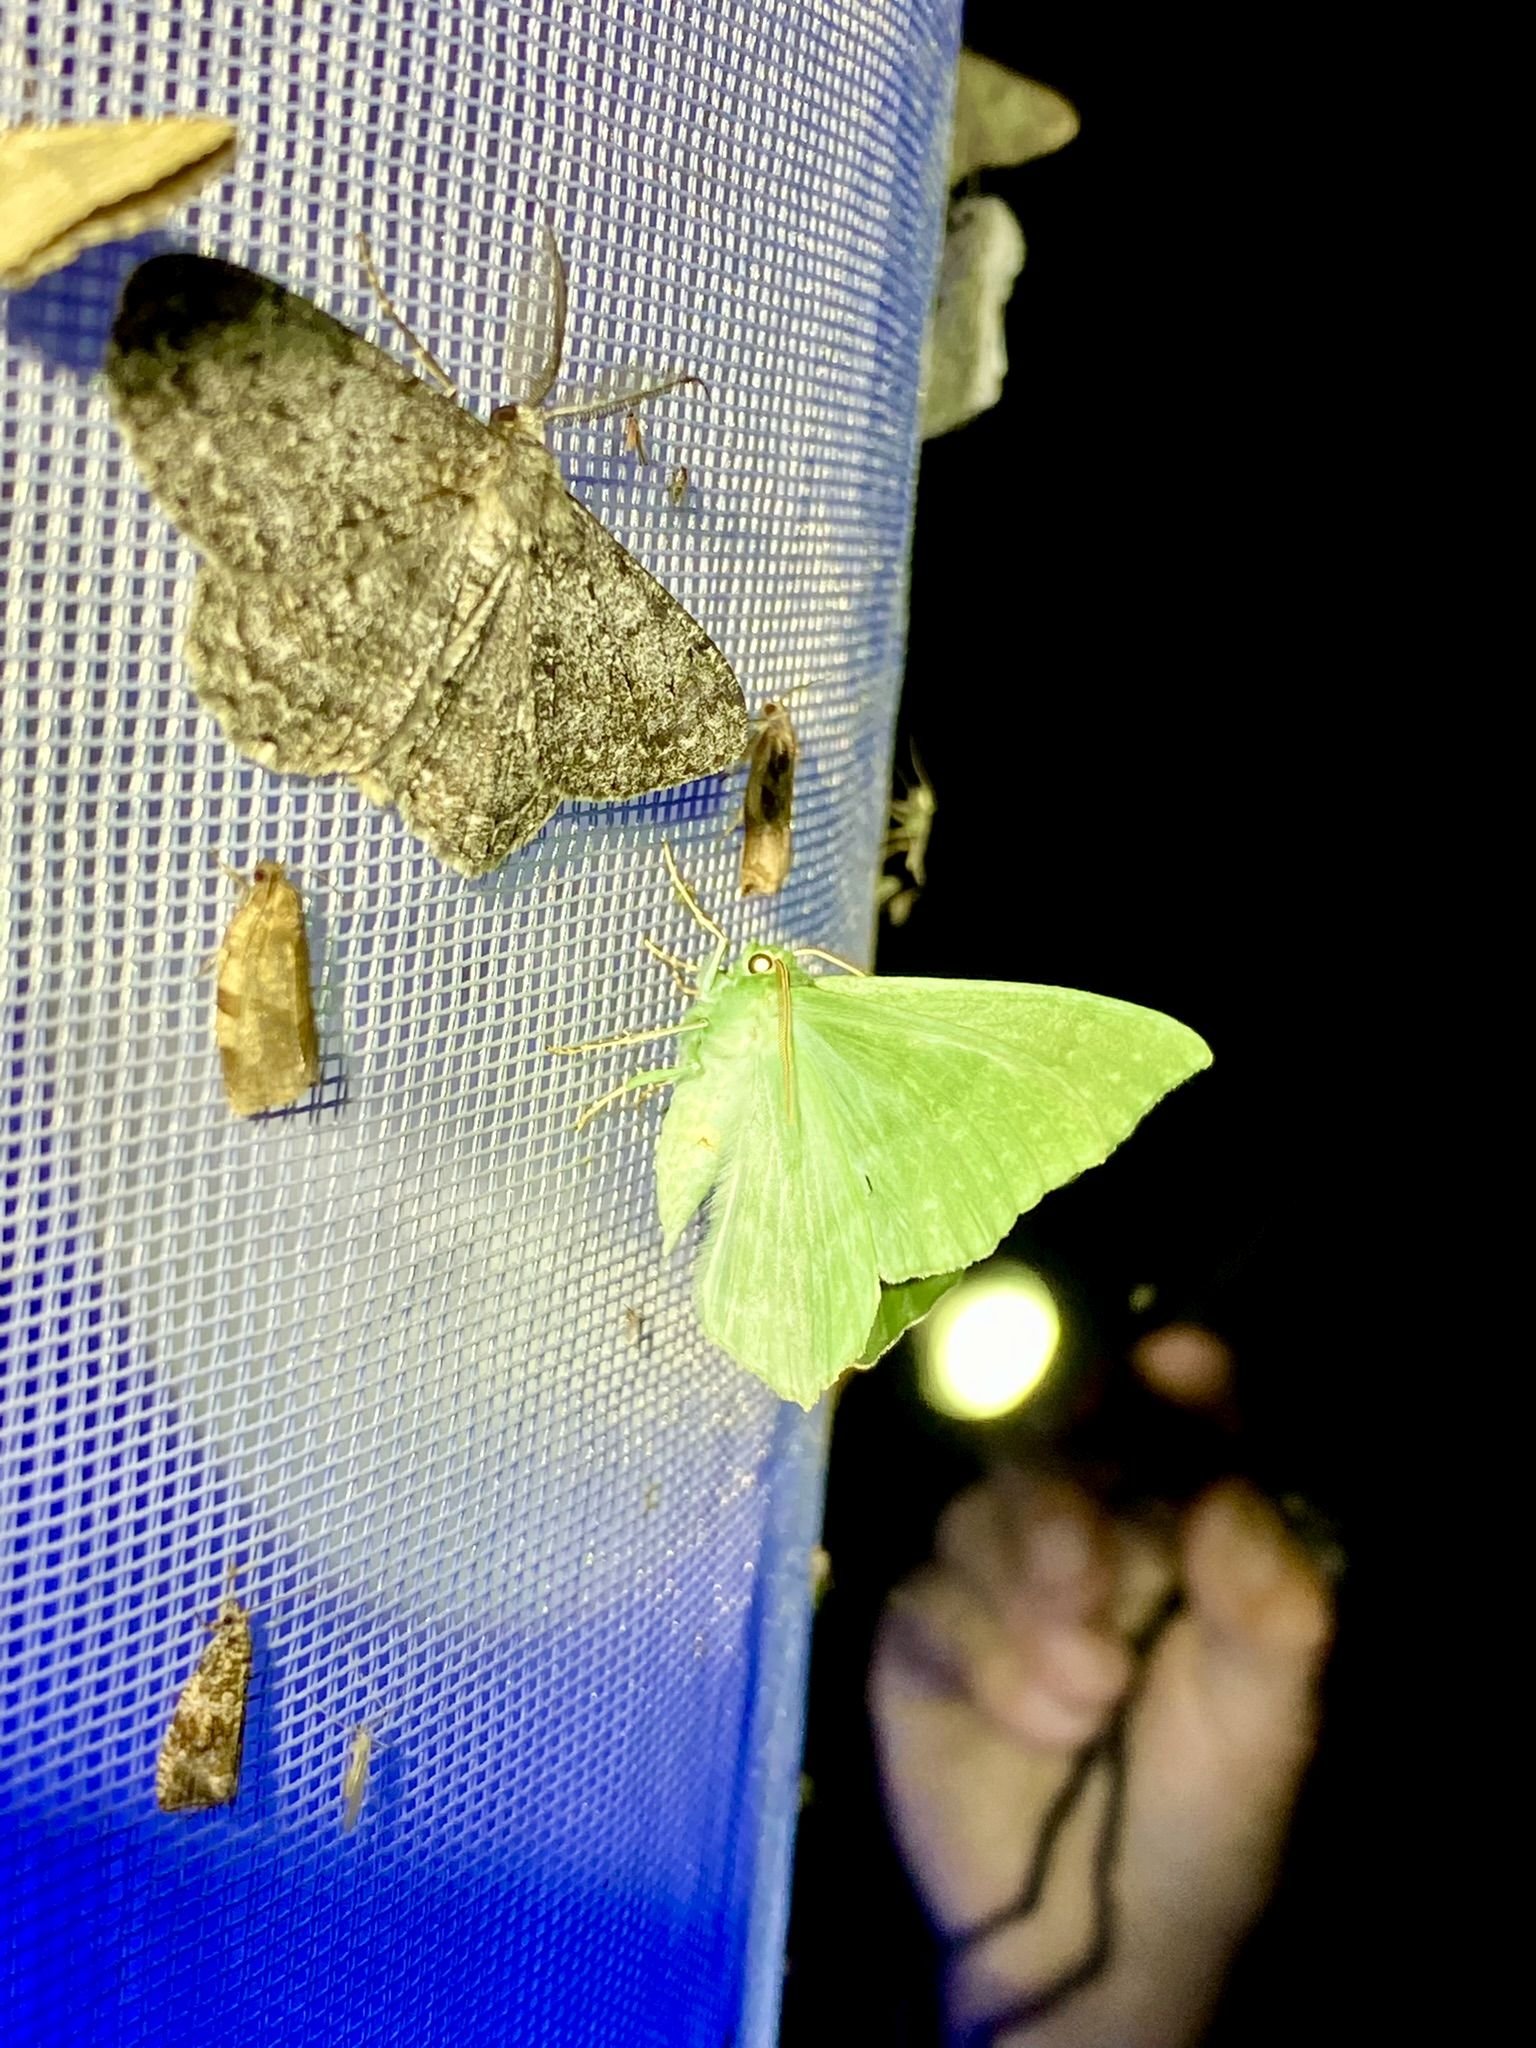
left=551, top=854, right=1210, bottom=1407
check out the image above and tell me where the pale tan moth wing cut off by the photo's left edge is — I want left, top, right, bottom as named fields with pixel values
left=0, top=115, right=236, bottom=291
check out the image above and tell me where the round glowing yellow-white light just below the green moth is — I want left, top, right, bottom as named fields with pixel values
left=918, top=1260, right=1061, bottom=1421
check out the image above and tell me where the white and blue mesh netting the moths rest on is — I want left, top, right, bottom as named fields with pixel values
left=0, top=0, right=958, bottom=2048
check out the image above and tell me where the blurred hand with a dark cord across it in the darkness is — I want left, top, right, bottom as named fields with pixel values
left=870, top=1327, right=1331, bottom=2048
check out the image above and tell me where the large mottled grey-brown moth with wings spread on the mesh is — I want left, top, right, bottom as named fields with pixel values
left=106, top=256, right=748, bottom=874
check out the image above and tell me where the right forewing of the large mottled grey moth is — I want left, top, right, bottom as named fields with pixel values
left=530, top=487, right=748, bottom=797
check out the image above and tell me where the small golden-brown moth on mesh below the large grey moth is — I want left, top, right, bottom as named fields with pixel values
left=213, top=860, right=319, bottom=1116
